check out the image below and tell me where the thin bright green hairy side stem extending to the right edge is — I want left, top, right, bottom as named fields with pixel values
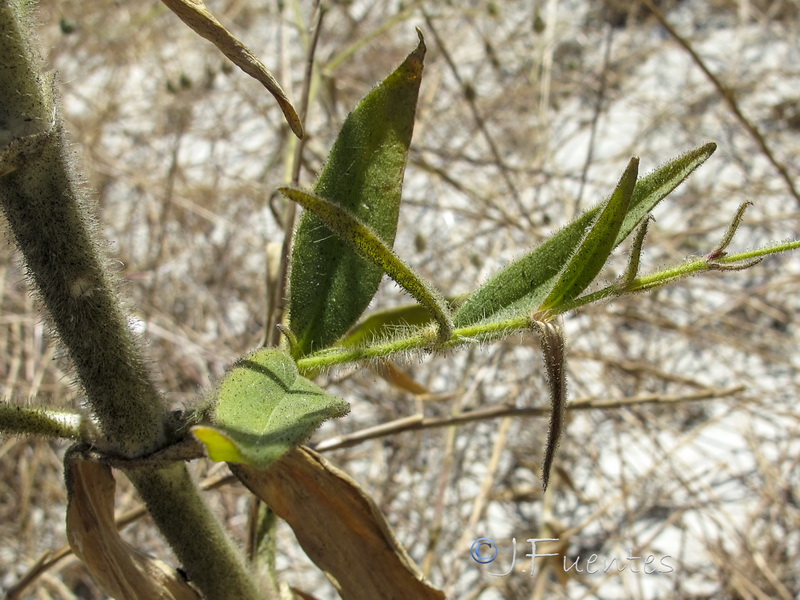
left=297, top=240, right=800, bottom=373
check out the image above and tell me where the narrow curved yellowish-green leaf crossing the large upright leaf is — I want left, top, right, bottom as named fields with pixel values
left=278, top=188, right=453, bottom=342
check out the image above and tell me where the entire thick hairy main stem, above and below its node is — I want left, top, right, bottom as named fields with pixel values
left=0, top=5, right=268, bottom=600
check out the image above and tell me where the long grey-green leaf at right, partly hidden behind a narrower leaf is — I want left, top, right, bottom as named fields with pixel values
left=455, top=142, right=717, bottom=327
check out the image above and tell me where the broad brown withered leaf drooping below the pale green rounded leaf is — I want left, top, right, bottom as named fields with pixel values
left=229, top=446, right=445, bottom=600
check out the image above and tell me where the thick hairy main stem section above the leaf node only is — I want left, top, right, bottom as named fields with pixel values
left=0, top=0, right=166, bottom=457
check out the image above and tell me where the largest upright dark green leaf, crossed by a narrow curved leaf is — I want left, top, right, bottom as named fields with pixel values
left=289, top=35, right=425, bottom=356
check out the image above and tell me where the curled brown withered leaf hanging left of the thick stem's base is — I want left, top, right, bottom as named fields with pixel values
left=66, top=458, right=200, bottom=600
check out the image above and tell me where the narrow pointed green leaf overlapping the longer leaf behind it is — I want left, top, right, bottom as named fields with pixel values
left=539, top=158, right=639, bottom=311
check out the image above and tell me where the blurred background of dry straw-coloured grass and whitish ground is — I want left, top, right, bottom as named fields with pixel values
left=0, top=0, right=800, bottom=600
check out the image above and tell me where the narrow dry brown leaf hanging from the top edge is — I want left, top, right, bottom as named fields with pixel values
left=161, top=0, right=303, bottom=138
